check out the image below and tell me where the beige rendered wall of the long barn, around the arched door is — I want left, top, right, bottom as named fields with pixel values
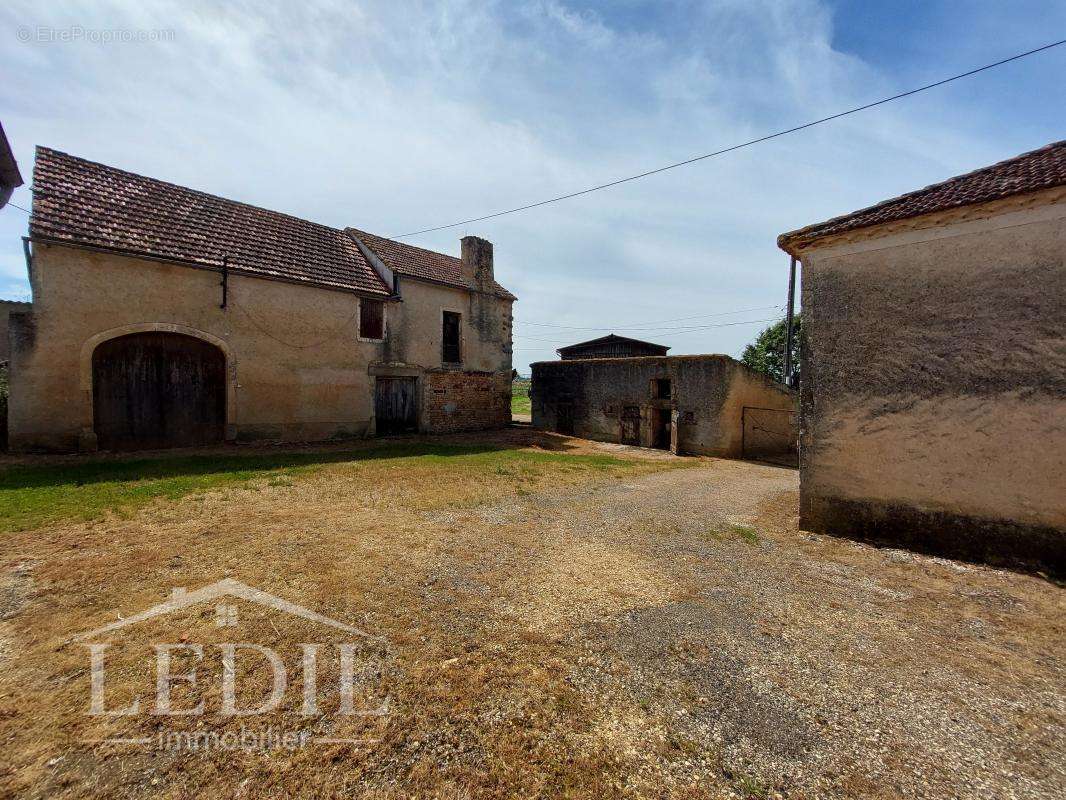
left=10, top=243, right=511, bottom=450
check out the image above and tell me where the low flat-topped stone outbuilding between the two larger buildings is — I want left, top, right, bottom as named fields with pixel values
left=530, top=355, right=795, bottom=458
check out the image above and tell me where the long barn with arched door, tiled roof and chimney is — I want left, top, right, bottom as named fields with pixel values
left=9, top=148, right=515, bottom=450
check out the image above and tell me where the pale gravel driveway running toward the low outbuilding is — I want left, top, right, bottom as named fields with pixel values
left=426, top=461, right=1066, bottom=798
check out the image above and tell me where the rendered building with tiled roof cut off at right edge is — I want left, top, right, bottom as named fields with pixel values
left=778, top=142, right=1066, bottom=573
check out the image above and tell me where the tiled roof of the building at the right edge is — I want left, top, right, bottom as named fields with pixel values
left=777, top=141, right=1066, bottom=251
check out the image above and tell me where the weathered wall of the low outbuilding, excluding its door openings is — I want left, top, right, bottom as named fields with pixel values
left=530, top=355, right=795, bottom=458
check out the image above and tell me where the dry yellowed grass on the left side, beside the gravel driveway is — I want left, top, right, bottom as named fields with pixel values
left=0, top=442, right=684, bottom=797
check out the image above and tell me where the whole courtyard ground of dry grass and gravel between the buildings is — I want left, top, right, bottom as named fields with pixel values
left=0, top=430, right=1066, bottom=798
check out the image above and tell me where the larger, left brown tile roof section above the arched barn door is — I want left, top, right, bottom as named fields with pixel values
left=30, top=147, right=390, bottom=295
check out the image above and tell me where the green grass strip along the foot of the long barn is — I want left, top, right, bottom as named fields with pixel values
left=0, top=442, right=640, bottom=531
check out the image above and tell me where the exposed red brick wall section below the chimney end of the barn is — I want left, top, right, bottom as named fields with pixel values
left=422, top=370, right=511, bottom=433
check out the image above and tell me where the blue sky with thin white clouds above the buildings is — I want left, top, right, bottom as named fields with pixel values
left=0, top=0, right=1066, bottom=371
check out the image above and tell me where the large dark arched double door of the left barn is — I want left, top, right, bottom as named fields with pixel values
left=93, top=333, right=226, bottom=450
